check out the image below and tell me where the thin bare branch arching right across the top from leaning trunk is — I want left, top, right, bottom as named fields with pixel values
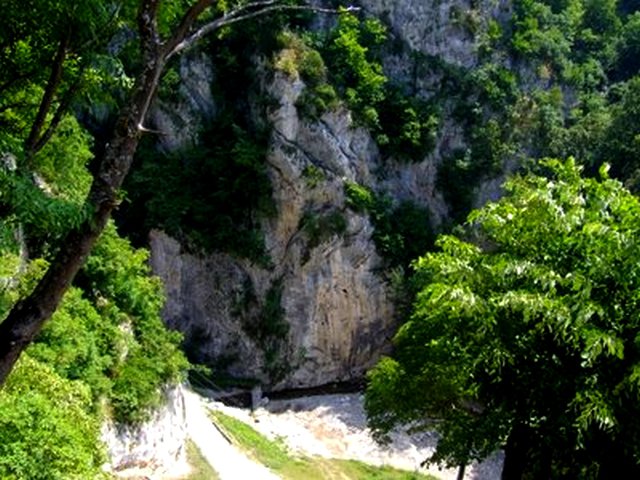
left=165, top=1, right=359, bottom=59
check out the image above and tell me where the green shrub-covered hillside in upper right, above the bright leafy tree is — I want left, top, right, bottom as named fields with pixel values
left=432, top=0, right=640, bottom=221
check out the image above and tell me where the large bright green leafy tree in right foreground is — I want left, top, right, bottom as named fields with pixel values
left=366, top=160, right=640, bottom=479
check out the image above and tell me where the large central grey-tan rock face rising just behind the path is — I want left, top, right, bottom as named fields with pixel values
left=151, top=70, right=393, bottom=387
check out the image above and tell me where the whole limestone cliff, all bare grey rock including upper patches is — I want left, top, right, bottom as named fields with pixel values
left=150, top=0, right=509, bottom=388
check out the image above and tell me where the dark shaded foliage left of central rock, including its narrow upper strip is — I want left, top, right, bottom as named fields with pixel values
left=118, top=17, right=284, bottom=268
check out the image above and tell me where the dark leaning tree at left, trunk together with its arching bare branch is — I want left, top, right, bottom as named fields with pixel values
left=0, top=0, right=350, bottom=385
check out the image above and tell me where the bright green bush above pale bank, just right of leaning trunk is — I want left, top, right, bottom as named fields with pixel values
left=81, top=226, right=188, bottom=422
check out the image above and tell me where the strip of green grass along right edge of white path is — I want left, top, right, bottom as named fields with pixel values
left=211, top=411, right=436, bottom=480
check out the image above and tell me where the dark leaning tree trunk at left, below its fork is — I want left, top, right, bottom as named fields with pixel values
left=0, top=43, right=164, bottom=387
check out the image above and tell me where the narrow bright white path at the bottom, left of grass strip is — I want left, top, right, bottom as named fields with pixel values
left=180, top=390, right=280, bottom=480
